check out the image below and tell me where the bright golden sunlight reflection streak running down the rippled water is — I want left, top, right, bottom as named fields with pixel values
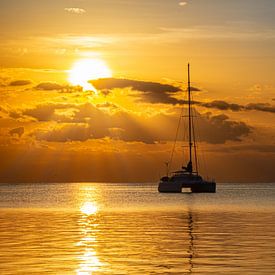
left=76, top=187, right=104, bottom=275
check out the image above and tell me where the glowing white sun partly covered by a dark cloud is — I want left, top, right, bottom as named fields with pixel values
left=68, top=59, right=112, bottom=91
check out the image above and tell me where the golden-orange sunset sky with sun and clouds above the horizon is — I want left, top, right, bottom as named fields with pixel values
left=0, top=0, right=275, bottom=182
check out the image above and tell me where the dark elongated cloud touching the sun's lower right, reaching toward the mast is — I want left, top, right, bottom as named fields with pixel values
left=90, top=78, right=186, bottom=105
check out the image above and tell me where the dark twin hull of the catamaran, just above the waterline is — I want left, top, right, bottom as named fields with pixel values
left=158, top=181, right=216, bottom=193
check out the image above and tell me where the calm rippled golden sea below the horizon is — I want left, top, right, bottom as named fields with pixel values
left=0, top=183, right=275, bottom=274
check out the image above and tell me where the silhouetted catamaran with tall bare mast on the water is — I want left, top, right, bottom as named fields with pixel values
left=158, top=64, right=216, bottom=193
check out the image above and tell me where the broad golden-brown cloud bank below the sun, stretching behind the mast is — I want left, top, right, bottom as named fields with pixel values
left=22, top=103, right=252, bottom=144
